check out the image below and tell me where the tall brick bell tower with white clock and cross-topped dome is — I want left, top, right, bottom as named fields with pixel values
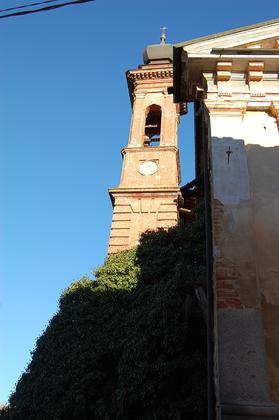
left=108, top=32, right=185, bottom=254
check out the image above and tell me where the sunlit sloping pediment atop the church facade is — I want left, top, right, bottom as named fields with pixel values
left=175, top=19, right=279, bottom=55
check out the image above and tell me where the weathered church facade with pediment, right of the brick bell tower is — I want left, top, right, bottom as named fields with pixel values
left=174, top=19, right=279, bottom=420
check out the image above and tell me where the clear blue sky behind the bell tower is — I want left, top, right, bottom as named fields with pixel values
left=0, top=0, right=278, bottom=403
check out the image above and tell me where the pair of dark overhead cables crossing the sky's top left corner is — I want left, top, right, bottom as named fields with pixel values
left=0, top=0, right=95, bottom=19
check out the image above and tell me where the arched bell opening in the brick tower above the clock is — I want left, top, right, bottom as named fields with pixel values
left=143, top=105, right=162, bottom=147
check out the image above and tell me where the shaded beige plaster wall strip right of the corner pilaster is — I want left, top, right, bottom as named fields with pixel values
left=246, top=145, right=279, bottom=404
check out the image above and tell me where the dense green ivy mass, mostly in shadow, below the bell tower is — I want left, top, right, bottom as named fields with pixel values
left=6, top=207, right=206, bottom=420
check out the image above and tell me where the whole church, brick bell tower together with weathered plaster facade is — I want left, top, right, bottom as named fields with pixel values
left=109, top=19, right=279, bottom=420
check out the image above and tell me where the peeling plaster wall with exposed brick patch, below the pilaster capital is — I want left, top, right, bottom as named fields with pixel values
left=210, top=111, right=279, bottom=404
